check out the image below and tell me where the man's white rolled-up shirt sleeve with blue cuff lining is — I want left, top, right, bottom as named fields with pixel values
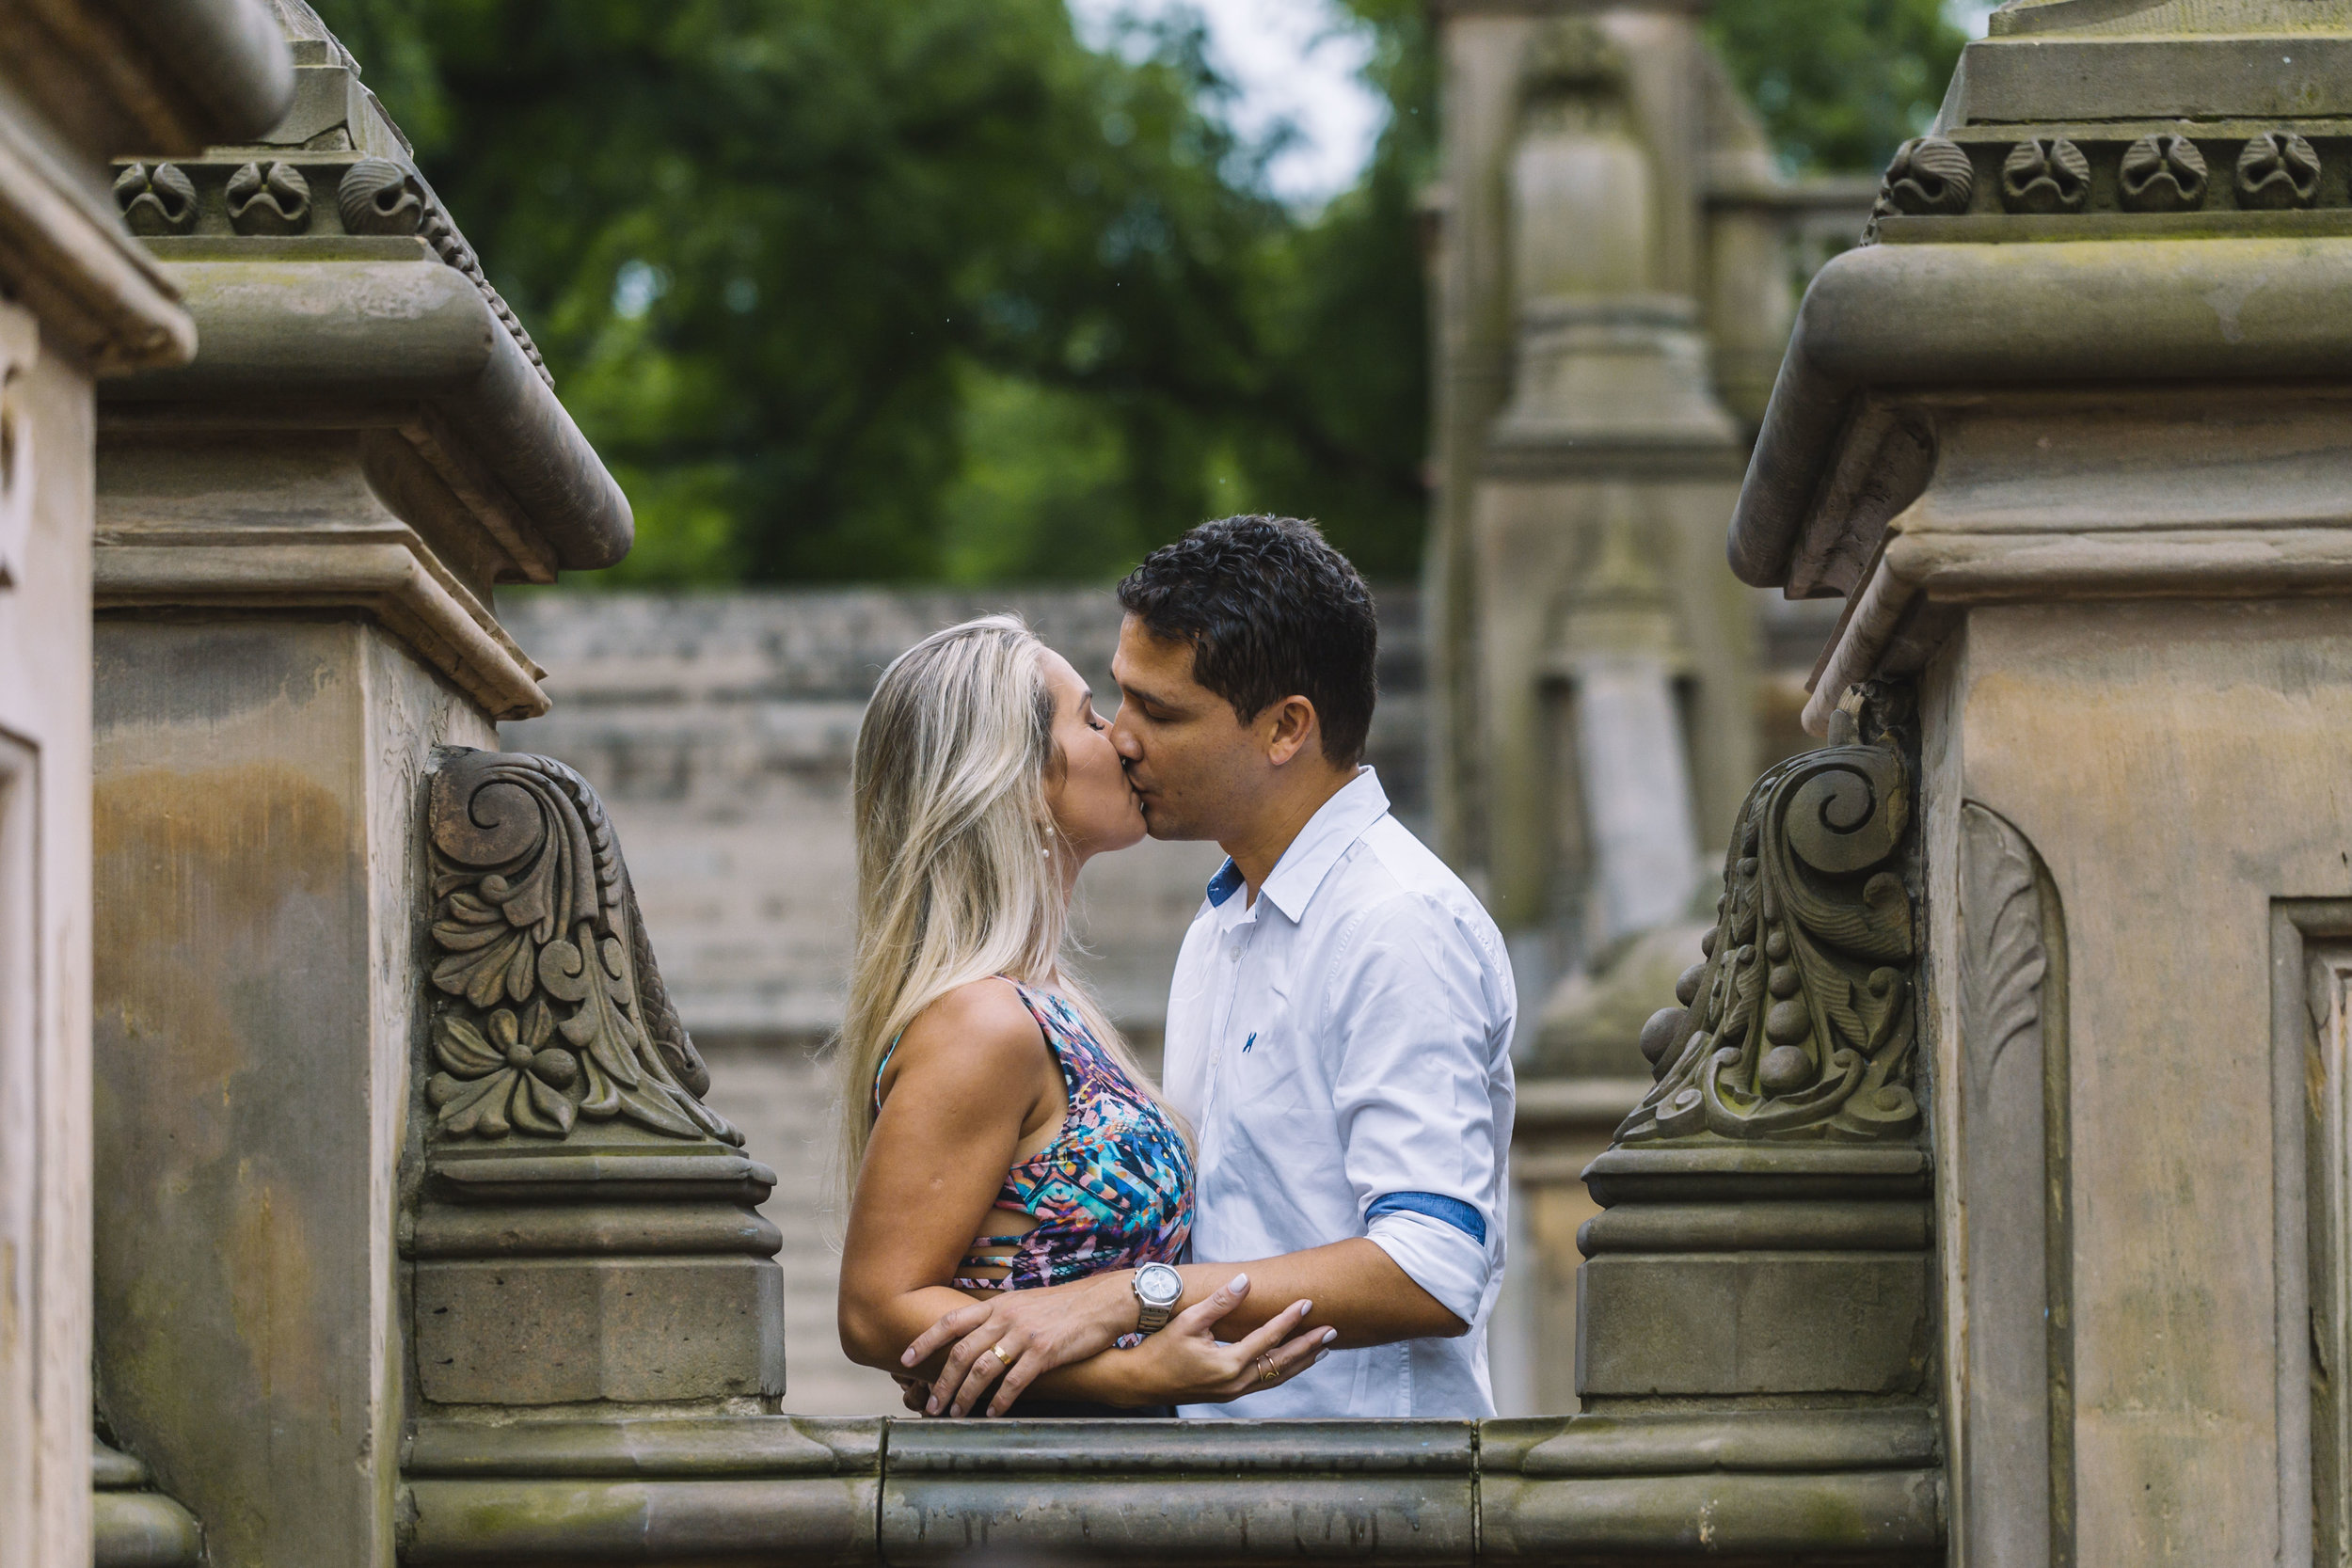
left=1325, top=895, right=1510, bottom=1323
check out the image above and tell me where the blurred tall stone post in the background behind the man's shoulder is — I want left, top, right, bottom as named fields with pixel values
left=1423, top=0, right=1870, bottom=1411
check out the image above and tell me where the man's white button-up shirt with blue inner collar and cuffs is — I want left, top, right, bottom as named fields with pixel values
left=1165, top=768, right=1518, bottom=1420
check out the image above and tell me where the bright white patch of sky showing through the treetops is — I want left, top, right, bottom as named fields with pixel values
left=1071, top=0, right=1388, bottom=207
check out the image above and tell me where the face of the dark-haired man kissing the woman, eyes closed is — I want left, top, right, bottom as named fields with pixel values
left=1110, top=616, right=1270, bottom=839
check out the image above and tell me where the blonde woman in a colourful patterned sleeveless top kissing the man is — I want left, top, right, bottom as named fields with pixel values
left=840, top=616, right=1329, bottom=1416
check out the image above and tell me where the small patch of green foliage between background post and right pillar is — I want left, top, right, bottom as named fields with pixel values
left=1708, top=0, right=1966, bottom=171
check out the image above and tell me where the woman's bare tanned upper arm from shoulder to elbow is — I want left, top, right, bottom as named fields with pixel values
left=837, top=980, right=1061, bottom=1373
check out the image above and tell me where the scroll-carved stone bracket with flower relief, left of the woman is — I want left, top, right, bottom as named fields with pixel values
left=409, top=752, right=784, bottom=1418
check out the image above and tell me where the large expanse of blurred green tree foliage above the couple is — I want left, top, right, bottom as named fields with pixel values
left=306, top=0, right=1425, bottom=580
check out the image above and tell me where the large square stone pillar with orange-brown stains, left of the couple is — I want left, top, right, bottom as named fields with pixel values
left=94, top=18, right=630, bottom=1568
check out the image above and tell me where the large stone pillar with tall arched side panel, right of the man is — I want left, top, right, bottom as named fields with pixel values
left=1731, top=0, right=2352, bottom=1568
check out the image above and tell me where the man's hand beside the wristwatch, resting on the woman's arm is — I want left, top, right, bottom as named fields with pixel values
left=898, top=1270, right=1136, bottom=1416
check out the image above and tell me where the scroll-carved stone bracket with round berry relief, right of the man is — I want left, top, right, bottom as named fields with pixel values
left=1576, top=710, right=1933, bottom=1432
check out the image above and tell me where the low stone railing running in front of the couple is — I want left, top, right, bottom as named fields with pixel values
left=403, top=1406, right=1946, bottom=1566
